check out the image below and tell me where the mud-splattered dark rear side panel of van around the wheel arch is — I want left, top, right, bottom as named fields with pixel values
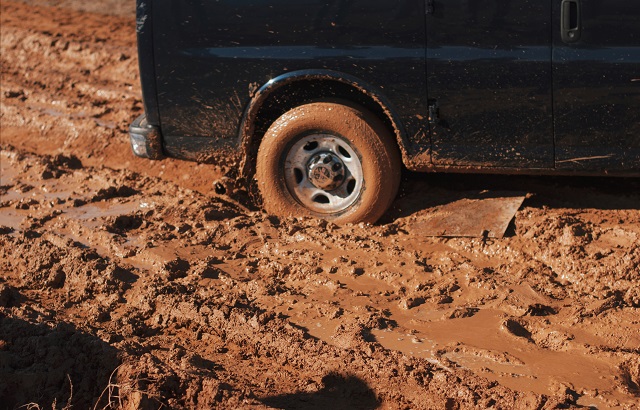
left=153, top=0, right=429, bottom=159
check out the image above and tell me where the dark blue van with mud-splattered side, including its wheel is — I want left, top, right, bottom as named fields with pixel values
left=130, top=0, right=640, bottom=223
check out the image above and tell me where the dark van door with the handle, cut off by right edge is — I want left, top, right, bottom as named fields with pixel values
left=553, top=0, right=640, bottom=172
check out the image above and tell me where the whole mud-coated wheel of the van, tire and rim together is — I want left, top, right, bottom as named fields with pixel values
left=256, top=102, right=401, bottom=224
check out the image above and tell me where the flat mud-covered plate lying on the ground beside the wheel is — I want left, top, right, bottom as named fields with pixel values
left=413, top=192, right=525, bottom=238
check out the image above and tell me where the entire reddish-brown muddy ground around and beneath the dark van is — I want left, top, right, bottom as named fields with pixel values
left=0, top=0, right=640, bottom=409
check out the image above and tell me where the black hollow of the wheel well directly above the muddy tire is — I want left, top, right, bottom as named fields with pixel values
left=242, top=79, right=401, bottom=180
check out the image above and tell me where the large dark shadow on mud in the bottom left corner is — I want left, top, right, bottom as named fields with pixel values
left=0, top=312, right=119, bottom=409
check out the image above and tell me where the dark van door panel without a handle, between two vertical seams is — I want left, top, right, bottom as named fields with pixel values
left=426, top=0, right=554, bottom=168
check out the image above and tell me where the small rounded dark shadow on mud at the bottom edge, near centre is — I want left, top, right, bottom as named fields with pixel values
left=260, top=373, right=381, bottom=410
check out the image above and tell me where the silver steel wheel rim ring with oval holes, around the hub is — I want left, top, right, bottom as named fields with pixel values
left=284, top=134, right=364, bottom=215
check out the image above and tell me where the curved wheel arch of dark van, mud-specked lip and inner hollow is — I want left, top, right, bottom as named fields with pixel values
left=238, top=70, right=407, bottom=182
